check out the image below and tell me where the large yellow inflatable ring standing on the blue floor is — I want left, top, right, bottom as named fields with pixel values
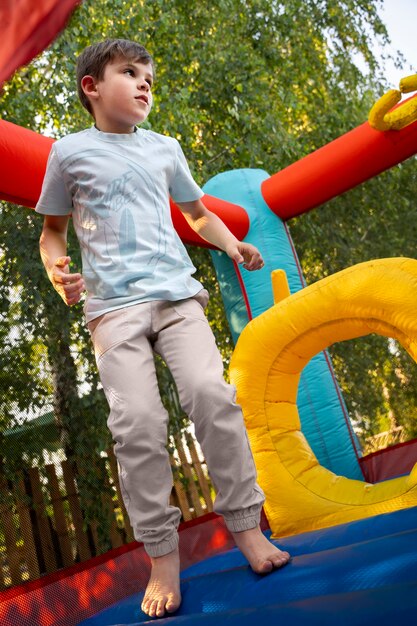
left=230, top=258, right=417, bottom=537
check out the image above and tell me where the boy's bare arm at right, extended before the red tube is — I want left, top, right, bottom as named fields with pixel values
left=177, top=200, right=264, bottom=271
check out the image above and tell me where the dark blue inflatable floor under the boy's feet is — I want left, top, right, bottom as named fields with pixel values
left=79, top=508, right=417, bottom=626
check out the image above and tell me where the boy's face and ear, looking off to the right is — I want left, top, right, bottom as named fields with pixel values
left=82, top=57, right=153, bottom=133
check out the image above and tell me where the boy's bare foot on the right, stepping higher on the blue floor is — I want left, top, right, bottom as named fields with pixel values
left=232, top=526, right=291, bottom=574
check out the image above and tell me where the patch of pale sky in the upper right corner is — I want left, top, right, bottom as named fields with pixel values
left=380, top=0, right=417, bottom=89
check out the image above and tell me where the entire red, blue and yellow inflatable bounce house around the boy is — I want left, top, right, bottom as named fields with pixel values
left=0, top=0, right=417, bottom=626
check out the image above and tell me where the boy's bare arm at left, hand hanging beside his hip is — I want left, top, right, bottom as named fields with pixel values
left=39, top=215, right=85, bottom=306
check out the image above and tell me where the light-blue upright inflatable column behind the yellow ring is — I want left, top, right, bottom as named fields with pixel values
left=204, top=169, right=363, bottom=480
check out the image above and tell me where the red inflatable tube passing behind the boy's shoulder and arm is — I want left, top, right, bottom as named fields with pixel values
left=0, top=120, right=249, bottom=248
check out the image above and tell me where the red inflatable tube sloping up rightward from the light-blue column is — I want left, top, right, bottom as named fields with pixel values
left=262, top=96, right=417, bottom=220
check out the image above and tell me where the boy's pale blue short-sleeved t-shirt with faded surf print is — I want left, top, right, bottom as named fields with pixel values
left=36, top=127, right=203, bottom=322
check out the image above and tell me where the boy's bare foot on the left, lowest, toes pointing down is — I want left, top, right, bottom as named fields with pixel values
left=141, top=549, right=181, bottom=617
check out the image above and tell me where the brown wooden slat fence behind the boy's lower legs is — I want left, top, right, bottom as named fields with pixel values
left=0, top=433, right=213, bottom=589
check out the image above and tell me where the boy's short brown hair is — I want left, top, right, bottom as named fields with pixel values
left=77, top=39, right=154, bottom=114
